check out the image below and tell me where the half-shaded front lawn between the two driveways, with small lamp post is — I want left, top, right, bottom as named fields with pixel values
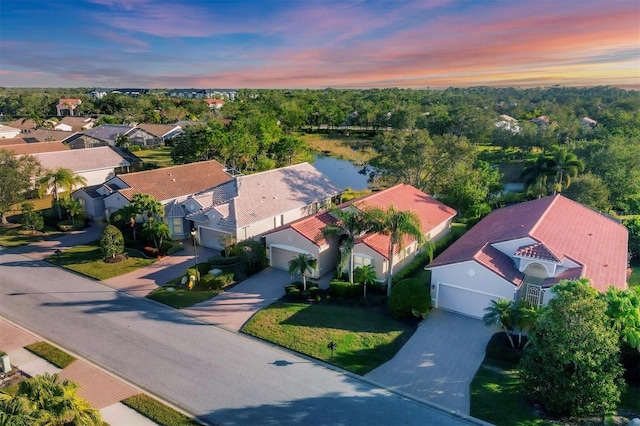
left=242, top=302, right=414, bottom=374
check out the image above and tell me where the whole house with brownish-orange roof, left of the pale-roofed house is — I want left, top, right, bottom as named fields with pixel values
left=84, top=160, right=233, bottom=233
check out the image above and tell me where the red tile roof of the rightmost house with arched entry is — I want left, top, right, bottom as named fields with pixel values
left=429, top=195, right=628, bottom=291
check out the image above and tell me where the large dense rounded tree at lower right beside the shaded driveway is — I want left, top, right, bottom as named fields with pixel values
left=520, top=280, right=623, bottom=416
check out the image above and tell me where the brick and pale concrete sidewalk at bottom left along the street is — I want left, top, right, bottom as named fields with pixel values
left=0, top=317, right=156, bottom=426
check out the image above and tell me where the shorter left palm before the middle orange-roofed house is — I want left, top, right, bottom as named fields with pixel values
left=322, top=206, right=372, bottom=284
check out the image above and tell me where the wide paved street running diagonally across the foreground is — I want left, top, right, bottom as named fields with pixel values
left=0, top=248, right=474, bottom=425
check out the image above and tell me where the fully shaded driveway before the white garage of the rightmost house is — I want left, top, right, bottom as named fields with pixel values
left=365, top=309, right=495, bottom=414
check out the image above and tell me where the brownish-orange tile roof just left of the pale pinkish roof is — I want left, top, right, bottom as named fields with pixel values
left=118, top=160, right=233, bottom=201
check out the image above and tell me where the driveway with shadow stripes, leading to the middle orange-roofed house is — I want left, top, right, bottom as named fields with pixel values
left=183, top=268, right=332, bottom=331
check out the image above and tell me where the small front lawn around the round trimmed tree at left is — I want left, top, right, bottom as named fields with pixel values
left=47, top=241, right=156, bottom=280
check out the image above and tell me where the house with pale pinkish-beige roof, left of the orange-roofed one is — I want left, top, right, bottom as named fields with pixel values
left=185, top=163, right=342, bottom=249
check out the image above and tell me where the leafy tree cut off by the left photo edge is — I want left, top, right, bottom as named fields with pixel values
left=0, top=149, right=40, bottom=224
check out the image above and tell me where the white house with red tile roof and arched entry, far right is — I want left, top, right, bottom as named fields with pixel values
left=427, top=195, right=628, bottom=318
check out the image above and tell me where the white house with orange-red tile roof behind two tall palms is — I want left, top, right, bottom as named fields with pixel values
left=264, top=184, right=456, bottom=281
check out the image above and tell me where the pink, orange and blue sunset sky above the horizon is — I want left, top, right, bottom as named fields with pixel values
left=0, top=0, right=640, bottom=89
